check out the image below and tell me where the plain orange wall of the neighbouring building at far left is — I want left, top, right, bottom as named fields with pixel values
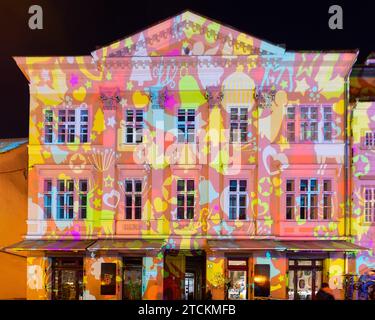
left=0, top=144, right=27, bottom=299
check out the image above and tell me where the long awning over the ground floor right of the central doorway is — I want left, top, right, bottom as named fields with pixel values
left=208, top=239, right=368, bottom=252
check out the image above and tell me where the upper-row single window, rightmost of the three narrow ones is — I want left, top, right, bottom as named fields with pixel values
left=230, top=108, right=248, bottom=143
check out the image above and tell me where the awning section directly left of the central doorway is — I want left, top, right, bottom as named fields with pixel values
left=87, top=239, right=163, bottom=251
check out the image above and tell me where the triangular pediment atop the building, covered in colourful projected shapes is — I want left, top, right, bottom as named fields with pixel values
left=92, top=10, right=285, bottom=60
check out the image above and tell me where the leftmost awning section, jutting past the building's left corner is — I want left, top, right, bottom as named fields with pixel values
left=3, top=240, right=94, bottom=252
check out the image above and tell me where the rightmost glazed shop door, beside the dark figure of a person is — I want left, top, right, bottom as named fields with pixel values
left=288, top=260, right=323, bottom=300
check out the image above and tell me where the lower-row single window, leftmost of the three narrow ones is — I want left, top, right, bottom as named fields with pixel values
left=125, top=179, right=142, bottom=220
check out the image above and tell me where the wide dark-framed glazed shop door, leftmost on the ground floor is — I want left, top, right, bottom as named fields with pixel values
left=52, top=258, right=83, bottom=300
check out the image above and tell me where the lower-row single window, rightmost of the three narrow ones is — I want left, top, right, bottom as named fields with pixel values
left=229, top=180, right=247, bottom=220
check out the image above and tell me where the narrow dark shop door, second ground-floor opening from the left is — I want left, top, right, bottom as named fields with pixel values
left=122, top=258, right=142, bottom=300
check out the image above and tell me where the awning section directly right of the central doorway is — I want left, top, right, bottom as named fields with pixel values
left=208, top=239, right=283, bottom=251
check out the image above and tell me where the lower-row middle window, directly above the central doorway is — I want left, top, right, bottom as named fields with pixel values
left=177, top=179, right=195, bottom=219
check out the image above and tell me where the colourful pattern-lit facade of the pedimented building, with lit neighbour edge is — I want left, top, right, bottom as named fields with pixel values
left=4, top=11, right=375, bottom=299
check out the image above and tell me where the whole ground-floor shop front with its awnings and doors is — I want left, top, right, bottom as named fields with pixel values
left=2, top=239, right=363, bottom=300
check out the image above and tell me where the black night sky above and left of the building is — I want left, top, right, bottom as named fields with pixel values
left=0, top=0, right=375, bottom=138
